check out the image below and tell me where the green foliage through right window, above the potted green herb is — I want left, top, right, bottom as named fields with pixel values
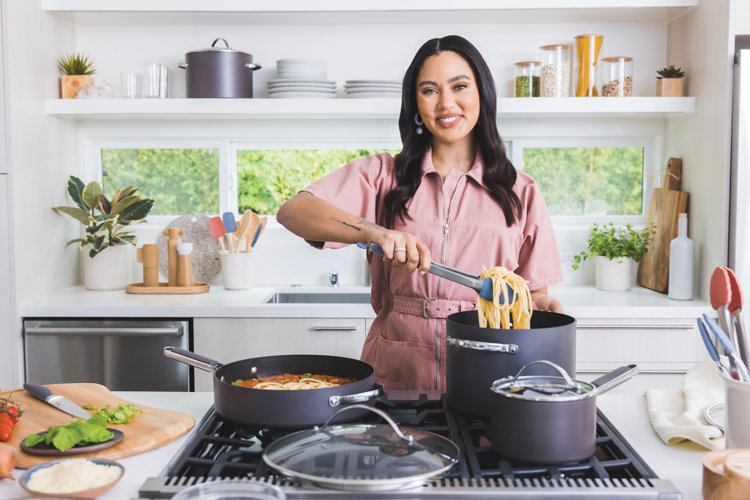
left=523, top=147, right=644, bottom=215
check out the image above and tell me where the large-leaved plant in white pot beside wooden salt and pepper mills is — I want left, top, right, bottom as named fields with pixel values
left=53, top=175, right=154, bottom=290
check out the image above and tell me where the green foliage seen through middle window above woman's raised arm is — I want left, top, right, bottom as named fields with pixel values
left=237, top=149, right=398, bottom=214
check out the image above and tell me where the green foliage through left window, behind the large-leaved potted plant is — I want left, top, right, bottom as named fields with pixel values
left=102, top=149, right=219, bottom=215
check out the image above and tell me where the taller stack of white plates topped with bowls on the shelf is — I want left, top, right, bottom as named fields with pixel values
left=268, top=59, right=336, bottom=99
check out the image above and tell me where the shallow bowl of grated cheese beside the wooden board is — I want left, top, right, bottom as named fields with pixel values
left=18, top=458, right=125, bottom=498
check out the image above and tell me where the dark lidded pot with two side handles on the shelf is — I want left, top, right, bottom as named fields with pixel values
left=178, top=38, right=261, bottom=98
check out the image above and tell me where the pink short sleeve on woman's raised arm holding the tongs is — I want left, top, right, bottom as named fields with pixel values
left=302, top=153, right=393, bottom=248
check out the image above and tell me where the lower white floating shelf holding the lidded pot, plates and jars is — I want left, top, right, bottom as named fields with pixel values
left=44, top=97, right=695, bottom=120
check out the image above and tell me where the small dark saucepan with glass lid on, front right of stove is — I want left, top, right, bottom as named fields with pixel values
left=490, top=360, right=638, bottom=463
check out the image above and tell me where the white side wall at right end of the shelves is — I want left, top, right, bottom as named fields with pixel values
left=665, top=0, right=740, bottom=299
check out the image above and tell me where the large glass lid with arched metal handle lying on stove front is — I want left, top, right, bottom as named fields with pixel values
left=263, top=405, right=459, bottom=491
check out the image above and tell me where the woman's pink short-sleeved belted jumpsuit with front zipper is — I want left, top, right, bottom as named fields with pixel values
left=305, top=151, right=563, bottom=391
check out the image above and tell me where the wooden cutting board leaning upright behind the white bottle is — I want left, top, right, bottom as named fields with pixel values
left=637, top=158, right=688, bottom=293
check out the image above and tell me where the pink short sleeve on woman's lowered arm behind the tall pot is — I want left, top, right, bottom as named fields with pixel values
left=515, top=182, right=564, bottom=290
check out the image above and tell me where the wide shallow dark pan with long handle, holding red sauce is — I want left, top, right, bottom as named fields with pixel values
left=164, top=347, right=383, bottom=429
